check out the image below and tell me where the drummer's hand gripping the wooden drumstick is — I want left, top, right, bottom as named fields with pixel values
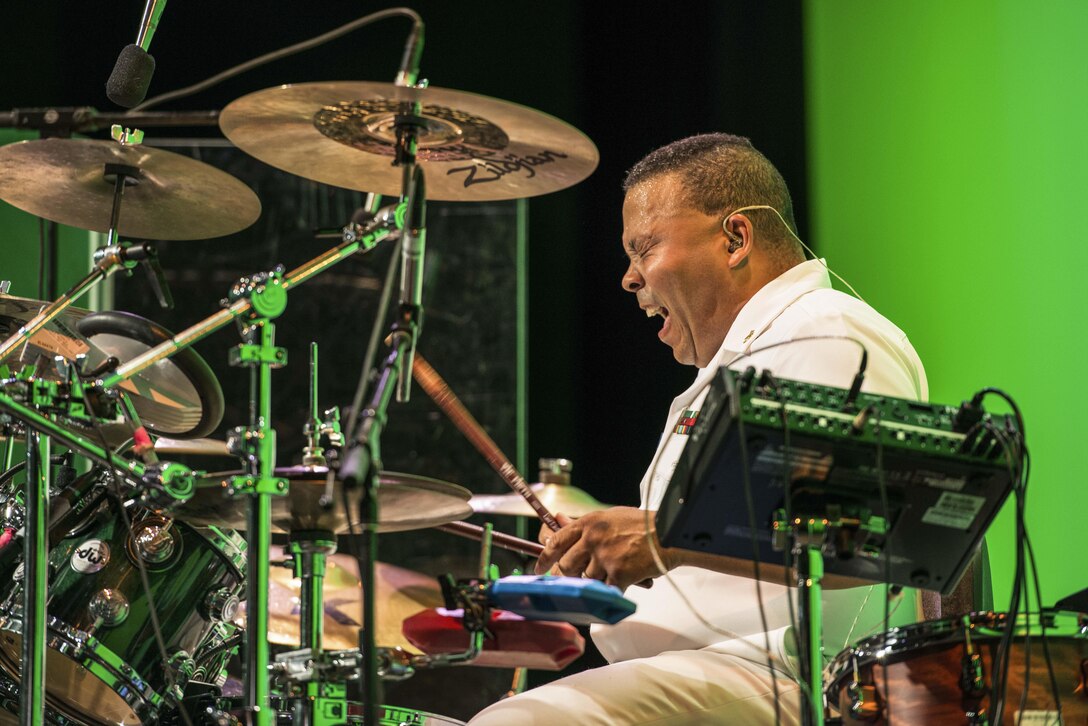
left=536, top=507, right=670, bottom=590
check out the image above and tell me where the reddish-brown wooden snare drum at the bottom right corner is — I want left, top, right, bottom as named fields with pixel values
left=827, top=613, right=1088, bottom=726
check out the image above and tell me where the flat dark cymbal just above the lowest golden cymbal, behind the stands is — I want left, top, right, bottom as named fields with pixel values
left=174, top=466, right=472, bottom=533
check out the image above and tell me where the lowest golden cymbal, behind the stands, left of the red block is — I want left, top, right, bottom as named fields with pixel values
left=235, top=546, right=443, bottom=653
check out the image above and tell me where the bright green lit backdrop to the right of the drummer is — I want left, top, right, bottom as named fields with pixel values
left=805, top=0, right=1088, bottom=610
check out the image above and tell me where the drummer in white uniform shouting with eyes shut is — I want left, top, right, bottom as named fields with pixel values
left=471, top=134, right=928, bottom=726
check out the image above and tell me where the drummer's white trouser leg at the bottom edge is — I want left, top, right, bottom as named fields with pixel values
left=469, top=650, right=800, bottom=726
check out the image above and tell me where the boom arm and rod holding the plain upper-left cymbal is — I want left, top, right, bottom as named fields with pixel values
left=0, top=126, right=158, bottom=362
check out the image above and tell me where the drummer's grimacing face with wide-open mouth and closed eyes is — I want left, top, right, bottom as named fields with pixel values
left=622, top=174, right=740, bottom=367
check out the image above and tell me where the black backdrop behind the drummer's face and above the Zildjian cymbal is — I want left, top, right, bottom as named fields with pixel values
left=0, top=0, right=806, bottom=511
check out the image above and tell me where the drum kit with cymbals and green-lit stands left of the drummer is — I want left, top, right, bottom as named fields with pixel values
left=0, top=75, right=618, bottom=724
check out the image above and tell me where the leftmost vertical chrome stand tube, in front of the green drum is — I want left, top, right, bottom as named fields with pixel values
left=20, top=432, right=49, bottom=726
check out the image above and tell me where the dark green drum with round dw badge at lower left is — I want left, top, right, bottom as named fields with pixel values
left=0, top=506, right=246, bottom=724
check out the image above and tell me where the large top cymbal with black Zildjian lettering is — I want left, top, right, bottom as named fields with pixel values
left=219, top=82, right=598, bottom=201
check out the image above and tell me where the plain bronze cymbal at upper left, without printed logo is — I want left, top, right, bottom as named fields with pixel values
left=0, top=138, right=261, bottom=239
